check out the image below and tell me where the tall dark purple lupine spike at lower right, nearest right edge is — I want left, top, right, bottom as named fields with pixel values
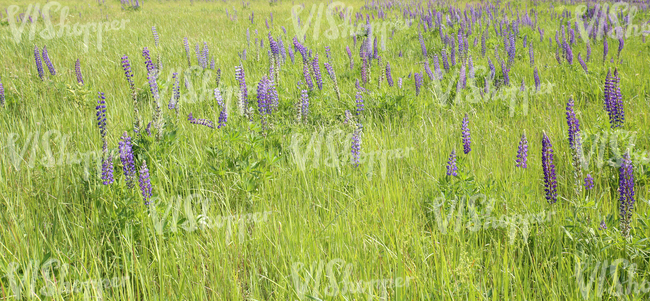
left=618, top=151, right=634, bottom=237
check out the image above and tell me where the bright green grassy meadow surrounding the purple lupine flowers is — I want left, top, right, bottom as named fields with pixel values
left=0, top=0, right=650, bottom=300
